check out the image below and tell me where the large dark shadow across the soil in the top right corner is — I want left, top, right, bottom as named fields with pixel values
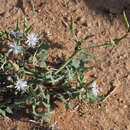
left=84, top=0, right=130, bottom=22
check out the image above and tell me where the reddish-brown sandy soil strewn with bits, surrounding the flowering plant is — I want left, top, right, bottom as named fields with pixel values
left=0, top=0, right=130, bottom=130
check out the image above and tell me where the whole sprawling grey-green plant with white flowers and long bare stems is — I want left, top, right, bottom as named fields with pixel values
left=0, top=13, right=130, bottom=120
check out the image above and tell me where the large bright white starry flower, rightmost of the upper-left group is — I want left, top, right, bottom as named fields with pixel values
left=27, top=33, right=38, bottom=47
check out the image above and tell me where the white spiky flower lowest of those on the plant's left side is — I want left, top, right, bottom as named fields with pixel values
left=15, top=79, right=27, bottom=91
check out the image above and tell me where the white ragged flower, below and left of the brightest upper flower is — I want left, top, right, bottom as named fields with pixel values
left=9, top=42, right=21, bottom=54
